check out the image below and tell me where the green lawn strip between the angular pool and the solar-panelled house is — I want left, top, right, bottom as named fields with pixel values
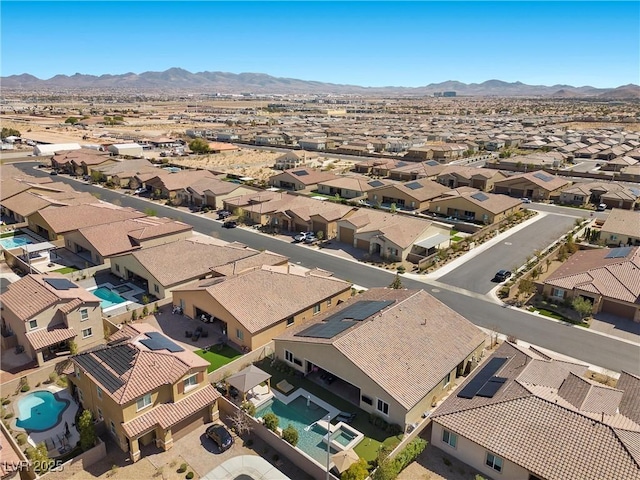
left=255, top=358, right=401, bottom=461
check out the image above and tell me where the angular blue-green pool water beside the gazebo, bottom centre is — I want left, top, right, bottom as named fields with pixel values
left=256, top=397, right=336, bottom=465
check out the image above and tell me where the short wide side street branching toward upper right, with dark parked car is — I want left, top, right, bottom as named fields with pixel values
left=438, top=213, right=575, bottom=294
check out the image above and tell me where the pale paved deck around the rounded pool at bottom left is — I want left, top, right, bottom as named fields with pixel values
left=11, top=385, right=80, bottom=458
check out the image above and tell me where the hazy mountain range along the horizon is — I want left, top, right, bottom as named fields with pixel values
left=0, top=68, right=640, bottom=99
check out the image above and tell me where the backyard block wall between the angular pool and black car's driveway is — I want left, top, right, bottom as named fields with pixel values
left=218, top=397, right=338, bottom=480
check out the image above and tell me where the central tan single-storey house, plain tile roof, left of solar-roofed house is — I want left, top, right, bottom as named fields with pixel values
left=173, top=265, right=351, bottom=350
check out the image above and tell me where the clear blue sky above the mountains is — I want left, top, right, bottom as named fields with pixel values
left=0, top=0, right=640, bottom=87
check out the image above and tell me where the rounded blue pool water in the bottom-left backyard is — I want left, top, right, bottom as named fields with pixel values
left=16, top=390, right=69, bottom=432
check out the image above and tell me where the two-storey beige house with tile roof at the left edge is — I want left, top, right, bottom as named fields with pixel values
left=0, top=273, right=104, bottom=366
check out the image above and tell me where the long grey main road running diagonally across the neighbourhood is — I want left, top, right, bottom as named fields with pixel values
left=10, top=164, right=640, bottom=374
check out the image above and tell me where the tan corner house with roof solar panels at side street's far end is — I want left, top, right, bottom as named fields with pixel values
left=429, top=189, right=523, bottom=225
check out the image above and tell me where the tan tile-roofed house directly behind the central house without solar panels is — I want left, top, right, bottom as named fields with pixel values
left=111, top=236, right=287, bottom=299
